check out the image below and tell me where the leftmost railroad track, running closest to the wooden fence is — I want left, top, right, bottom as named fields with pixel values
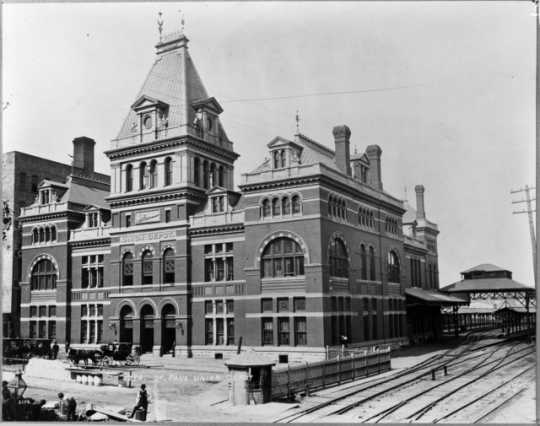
left=274, top=333, right=511, bottom=423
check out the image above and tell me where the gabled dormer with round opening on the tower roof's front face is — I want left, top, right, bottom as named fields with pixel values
left=131, top=95, right=169, bottom=143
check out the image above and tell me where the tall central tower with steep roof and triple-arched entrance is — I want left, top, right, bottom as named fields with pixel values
left=106, top=32, right=238, bottom=354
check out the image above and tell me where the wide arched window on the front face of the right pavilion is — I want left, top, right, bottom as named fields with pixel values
left=261, top=237, right=304, bottom=278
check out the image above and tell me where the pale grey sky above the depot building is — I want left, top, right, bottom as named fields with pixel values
left=2, top=2, right=536, bottom=286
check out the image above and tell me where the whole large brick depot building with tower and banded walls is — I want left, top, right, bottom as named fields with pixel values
left=18, top=33, right=438, bottom=359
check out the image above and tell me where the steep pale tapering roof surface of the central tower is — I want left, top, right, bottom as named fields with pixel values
left=117, top=33, right=215, bottom=142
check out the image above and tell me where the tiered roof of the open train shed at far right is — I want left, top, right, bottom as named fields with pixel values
left=441, top=263, right=535, bottom=293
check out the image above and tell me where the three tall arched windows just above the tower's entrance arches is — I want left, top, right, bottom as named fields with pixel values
left=122, top=248, right=175, bottom=286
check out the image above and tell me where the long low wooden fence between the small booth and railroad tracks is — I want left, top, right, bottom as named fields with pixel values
left=272, top=347, right=390, bottom=399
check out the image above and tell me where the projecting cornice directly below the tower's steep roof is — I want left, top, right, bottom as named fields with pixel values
left=104, top=135, right=240, bottom=162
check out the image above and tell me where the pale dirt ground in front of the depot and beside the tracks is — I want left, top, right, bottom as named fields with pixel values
left=6, top=347, right=536, bottom=424
